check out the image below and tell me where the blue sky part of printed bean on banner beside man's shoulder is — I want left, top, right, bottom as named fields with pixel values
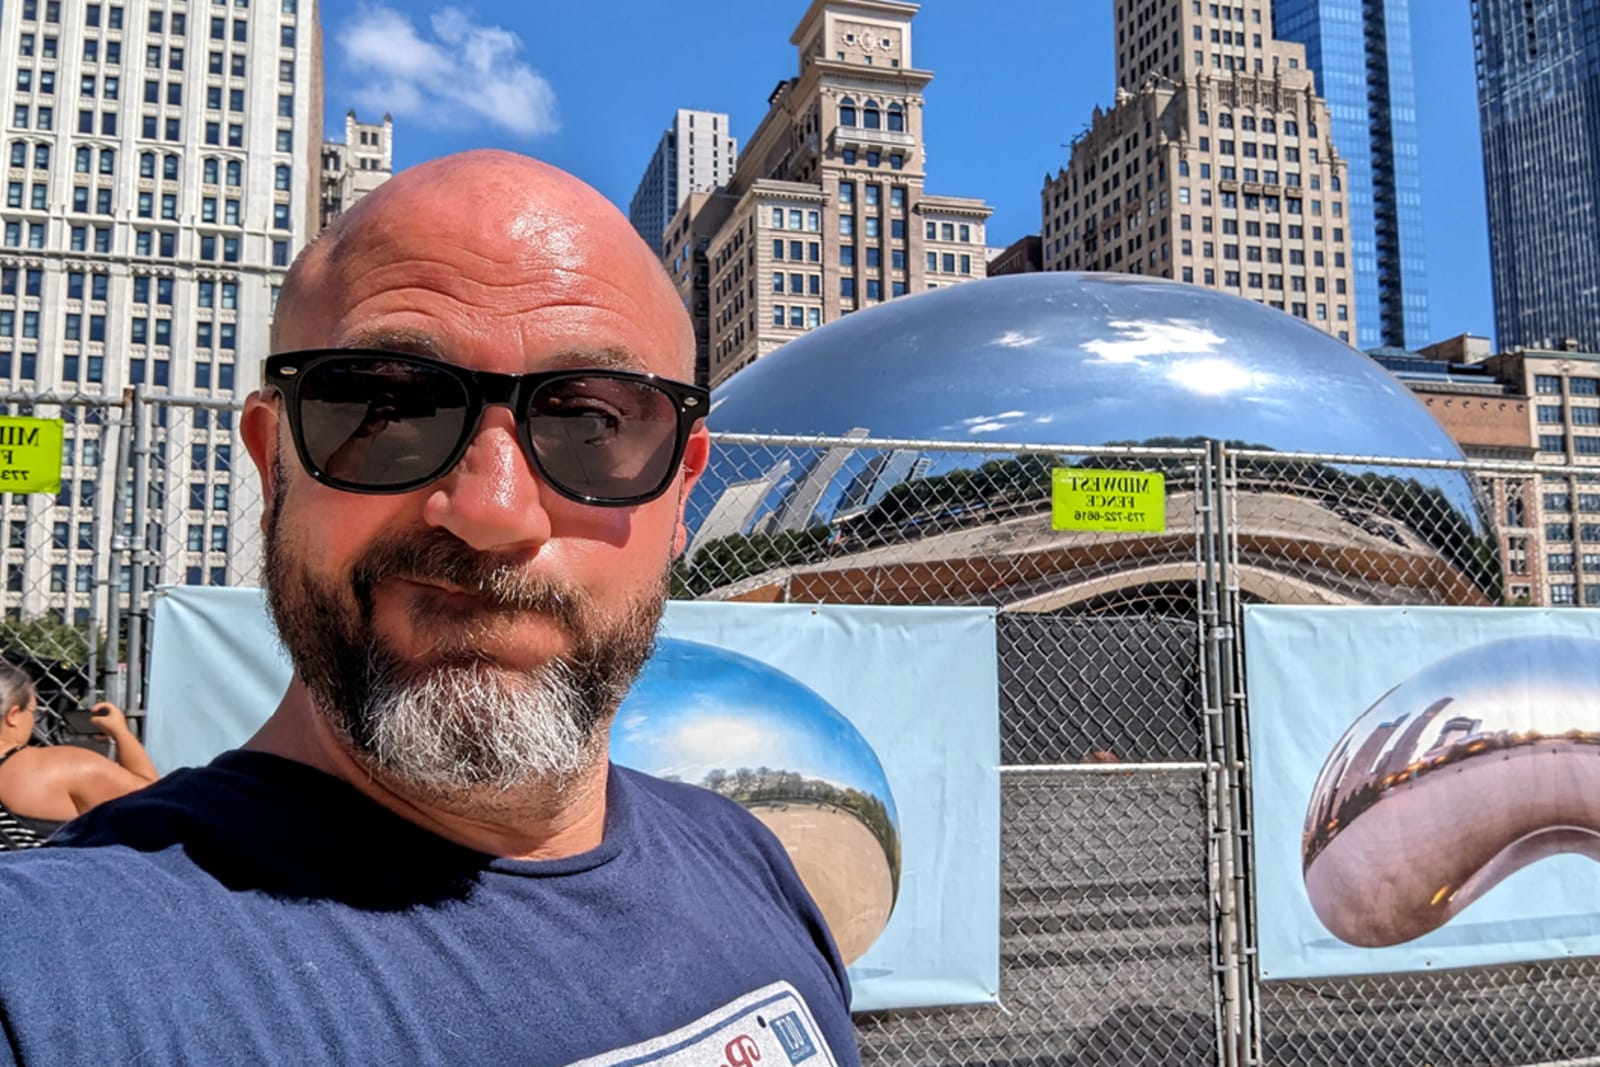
left=611, top=638, right=894, bottom=816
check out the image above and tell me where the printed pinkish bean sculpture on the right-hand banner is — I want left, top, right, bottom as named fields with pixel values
left=1302, top=635, right=1600, bottom=947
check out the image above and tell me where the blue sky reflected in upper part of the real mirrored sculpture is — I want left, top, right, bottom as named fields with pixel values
left=690, top=272, right=1480, bottom=539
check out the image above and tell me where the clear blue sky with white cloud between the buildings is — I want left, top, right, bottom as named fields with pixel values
left=322, top=0, right=1494, bottom=347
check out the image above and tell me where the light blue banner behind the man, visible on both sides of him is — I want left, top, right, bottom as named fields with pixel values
left=147, top=585, right=1000, bottom=1011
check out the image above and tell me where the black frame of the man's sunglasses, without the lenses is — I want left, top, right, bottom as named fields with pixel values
left=261, top=349, right=710, bottom=507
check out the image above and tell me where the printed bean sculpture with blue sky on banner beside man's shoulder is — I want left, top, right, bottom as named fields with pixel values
left=611, top=638, right=901, bottom=963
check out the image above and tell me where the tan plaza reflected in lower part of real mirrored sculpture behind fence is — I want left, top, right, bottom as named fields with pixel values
left=688, top=476, right=1488, bottom=613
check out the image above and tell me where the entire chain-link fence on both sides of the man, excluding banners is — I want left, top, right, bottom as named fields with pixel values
left=3, top=404, right=1600, bottom=1065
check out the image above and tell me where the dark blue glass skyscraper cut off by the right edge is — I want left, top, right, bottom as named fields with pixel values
left=1472, top=0, right=1600, bottom=352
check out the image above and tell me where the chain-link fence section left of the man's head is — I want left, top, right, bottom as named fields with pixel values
left=0, top=389, right=261, bottom=742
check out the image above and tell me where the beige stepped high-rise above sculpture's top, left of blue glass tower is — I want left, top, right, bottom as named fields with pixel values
left=1040, top=0, right=1355, bottom=341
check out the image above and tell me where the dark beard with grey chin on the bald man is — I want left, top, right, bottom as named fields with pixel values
left=266, top=475, right=667, bottom=795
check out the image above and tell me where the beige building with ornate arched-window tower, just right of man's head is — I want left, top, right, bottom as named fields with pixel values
left=662, top=0, right=990, bottom=384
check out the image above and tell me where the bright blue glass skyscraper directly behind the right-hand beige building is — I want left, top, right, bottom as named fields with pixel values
left=1272, top=0, right=1432, bottom=349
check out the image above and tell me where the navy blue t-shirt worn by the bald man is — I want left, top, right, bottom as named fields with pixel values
left=0, top=752, right=858, bottom=1067
